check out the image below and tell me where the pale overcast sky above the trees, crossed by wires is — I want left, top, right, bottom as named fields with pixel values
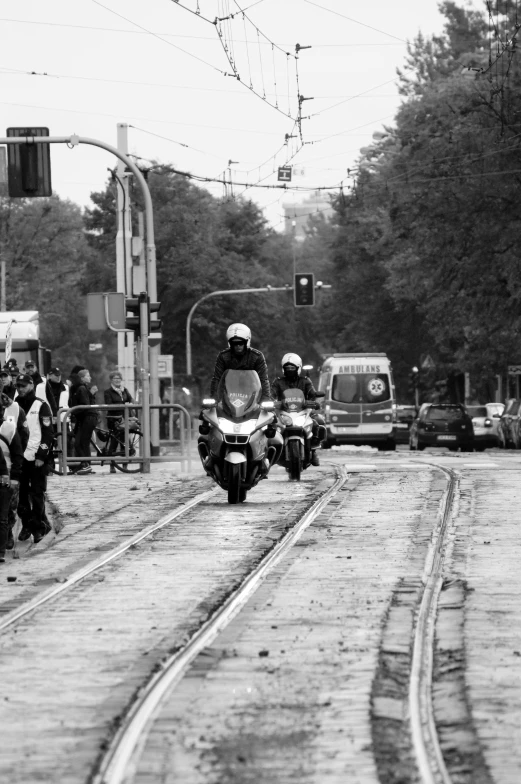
left=0, top=0, right=470, bottom=229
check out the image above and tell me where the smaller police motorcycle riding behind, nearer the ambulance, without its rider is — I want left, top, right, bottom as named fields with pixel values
left=278, top=389, right=325, bottom=481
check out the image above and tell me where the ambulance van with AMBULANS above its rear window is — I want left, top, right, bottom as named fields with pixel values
left=318, top=353, right=396, bottom=450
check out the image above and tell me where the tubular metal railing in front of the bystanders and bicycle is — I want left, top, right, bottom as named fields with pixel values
left=57, top=403, right=192, bottom=476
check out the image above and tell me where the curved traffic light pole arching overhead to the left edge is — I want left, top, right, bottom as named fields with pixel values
left=0, top=134, right=159, bottom=470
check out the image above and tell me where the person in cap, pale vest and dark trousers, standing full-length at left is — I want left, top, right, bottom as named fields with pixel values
left=15, top=373, right=54, bottom=544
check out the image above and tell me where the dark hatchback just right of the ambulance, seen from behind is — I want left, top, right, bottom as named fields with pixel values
left=409, top=403, right=474, bottom=452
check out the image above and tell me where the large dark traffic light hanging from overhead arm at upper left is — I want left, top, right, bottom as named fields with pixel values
left=7, top=128, right=52, bottom=198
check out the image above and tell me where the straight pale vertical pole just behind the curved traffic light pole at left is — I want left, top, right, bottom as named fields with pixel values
left=116, top=123, right=135, bottom=396
